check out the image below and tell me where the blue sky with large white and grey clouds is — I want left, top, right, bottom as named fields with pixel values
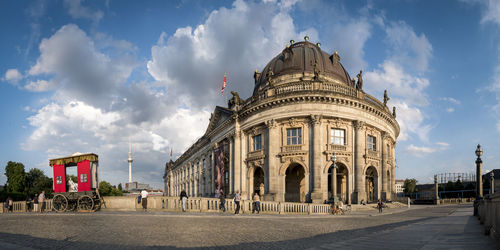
left=0, top=0, right=500, bottom=188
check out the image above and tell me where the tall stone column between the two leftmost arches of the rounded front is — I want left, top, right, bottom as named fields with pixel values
left=263, top=119, right=285, bottom=201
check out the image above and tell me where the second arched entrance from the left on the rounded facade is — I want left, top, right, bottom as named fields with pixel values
left=285, top=163, right=306, bottom=202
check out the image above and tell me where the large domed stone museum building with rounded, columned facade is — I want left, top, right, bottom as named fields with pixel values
left=164, top=37, right=400, bottom=203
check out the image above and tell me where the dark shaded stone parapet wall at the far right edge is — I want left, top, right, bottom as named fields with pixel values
left=478, top=193, right=500, bottom=238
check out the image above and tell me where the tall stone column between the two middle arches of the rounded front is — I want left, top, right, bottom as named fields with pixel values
left=309, top=115, right=323, bottom=203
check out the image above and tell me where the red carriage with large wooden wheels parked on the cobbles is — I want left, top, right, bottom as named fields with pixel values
left=49, top=153, right=102, bottom=212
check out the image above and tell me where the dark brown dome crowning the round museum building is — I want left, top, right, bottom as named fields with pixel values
left=254, top=37, right=354, bottom=94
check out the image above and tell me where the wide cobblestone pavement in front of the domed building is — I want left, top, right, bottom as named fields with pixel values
left=0, top=205, right=500, bottom=249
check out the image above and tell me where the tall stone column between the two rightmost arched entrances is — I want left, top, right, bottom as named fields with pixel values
left=353, top=121, right=366, bottom=204
